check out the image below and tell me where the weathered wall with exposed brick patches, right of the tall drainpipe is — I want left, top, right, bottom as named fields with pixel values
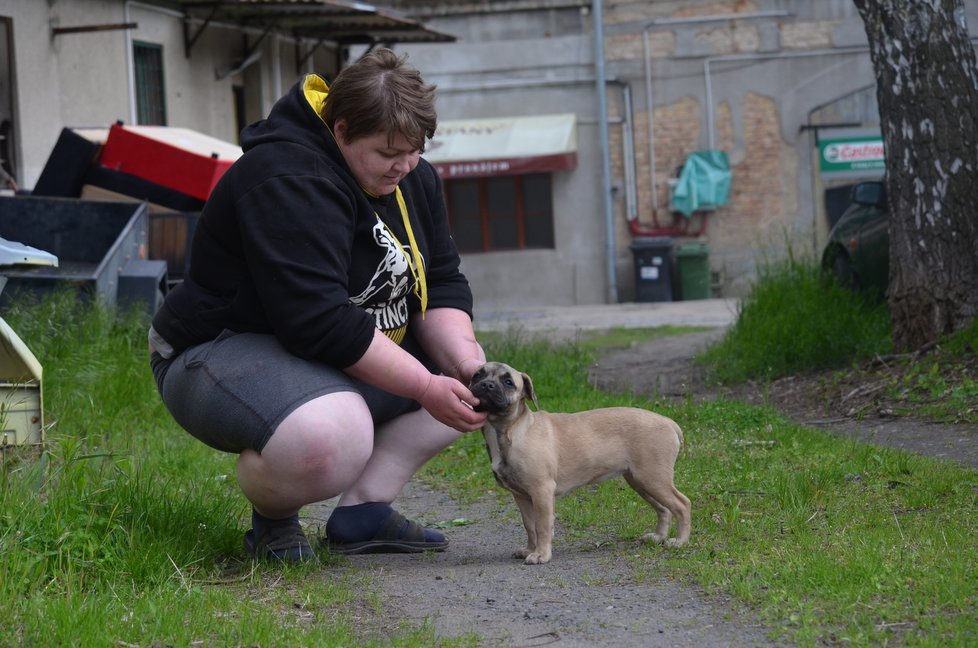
left=605, top=0, right=856, bottom=294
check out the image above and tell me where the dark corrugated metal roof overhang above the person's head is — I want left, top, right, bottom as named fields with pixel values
left=177, top=0, right=456, bottom=55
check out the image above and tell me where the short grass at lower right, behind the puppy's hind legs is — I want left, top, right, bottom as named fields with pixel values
left=647, top=403, right=978, bottom=646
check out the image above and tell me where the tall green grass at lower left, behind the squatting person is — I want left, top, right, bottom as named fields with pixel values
left=0, top=294, right=453, bottom=647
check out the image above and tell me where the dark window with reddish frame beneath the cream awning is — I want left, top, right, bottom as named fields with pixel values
left=445, top=173, right=554, bottom=252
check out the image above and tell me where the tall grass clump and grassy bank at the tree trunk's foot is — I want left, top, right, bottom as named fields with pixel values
left=696, top=258, right=978, bottom=423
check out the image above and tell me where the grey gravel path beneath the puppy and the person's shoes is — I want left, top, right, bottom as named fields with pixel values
left=314, top=482, right=775, bottom=648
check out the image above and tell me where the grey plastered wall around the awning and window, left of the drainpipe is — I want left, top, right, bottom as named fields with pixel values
left=388, top=31, right=608, bottom=308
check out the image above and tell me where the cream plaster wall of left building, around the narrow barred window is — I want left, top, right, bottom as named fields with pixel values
left=0, top=0, right=333, bottom=189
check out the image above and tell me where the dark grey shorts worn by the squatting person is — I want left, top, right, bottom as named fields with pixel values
left=150, top=331, right=434, bottom=453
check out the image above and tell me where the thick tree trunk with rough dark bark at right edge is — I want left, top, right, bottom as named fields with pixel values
left=853, top=0, right=978, bottom=351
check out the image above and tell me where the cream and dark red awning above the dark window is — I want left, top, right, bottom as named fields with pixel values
left=424, top=113, right=577, bottom=178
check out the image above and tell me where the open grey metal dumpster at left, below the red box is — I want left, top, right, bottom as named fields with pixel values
left=0, top=196, right=167, bottom=313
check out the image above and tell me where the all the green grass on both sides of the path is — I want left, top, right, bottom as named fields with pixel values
left=0, top=266, right=978, bottom=646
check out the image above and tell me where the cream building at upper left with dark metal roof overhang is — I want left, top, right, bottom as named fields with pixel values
left=0, top=0, right=454, bottom=182
